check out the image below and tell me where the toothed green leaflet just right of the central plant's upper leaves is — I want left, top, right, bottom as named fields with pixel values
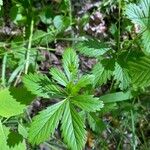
left=92, top=63, right=113, bottom=86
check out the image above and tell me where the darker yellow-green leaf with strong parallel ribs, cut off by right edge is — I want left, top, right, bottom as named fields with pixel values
left=129, top=57, right=150, bottom=88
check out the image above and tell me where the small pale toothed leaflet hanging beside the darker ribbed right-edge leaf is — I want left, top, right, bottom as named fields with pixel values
left=113, top=63, right=131, bottom=90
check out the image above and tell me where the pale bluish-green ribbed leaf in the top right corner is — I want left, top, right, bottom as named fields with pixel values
left=126, top=0, right=150, bottom=53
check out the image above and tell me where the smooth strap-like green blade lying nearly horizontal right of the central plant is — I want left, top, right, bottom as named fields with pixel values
left=100, top=91, right=133, bottom=104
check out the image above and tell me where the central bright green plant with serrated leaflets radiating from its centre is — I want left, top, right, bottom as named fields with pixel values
left=23, top=48, right=103, bottom=150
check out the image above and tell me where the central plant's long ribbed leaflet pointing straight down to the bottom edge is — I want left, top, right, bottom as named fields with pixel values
left=61, top=101, right=86, bottom=150
